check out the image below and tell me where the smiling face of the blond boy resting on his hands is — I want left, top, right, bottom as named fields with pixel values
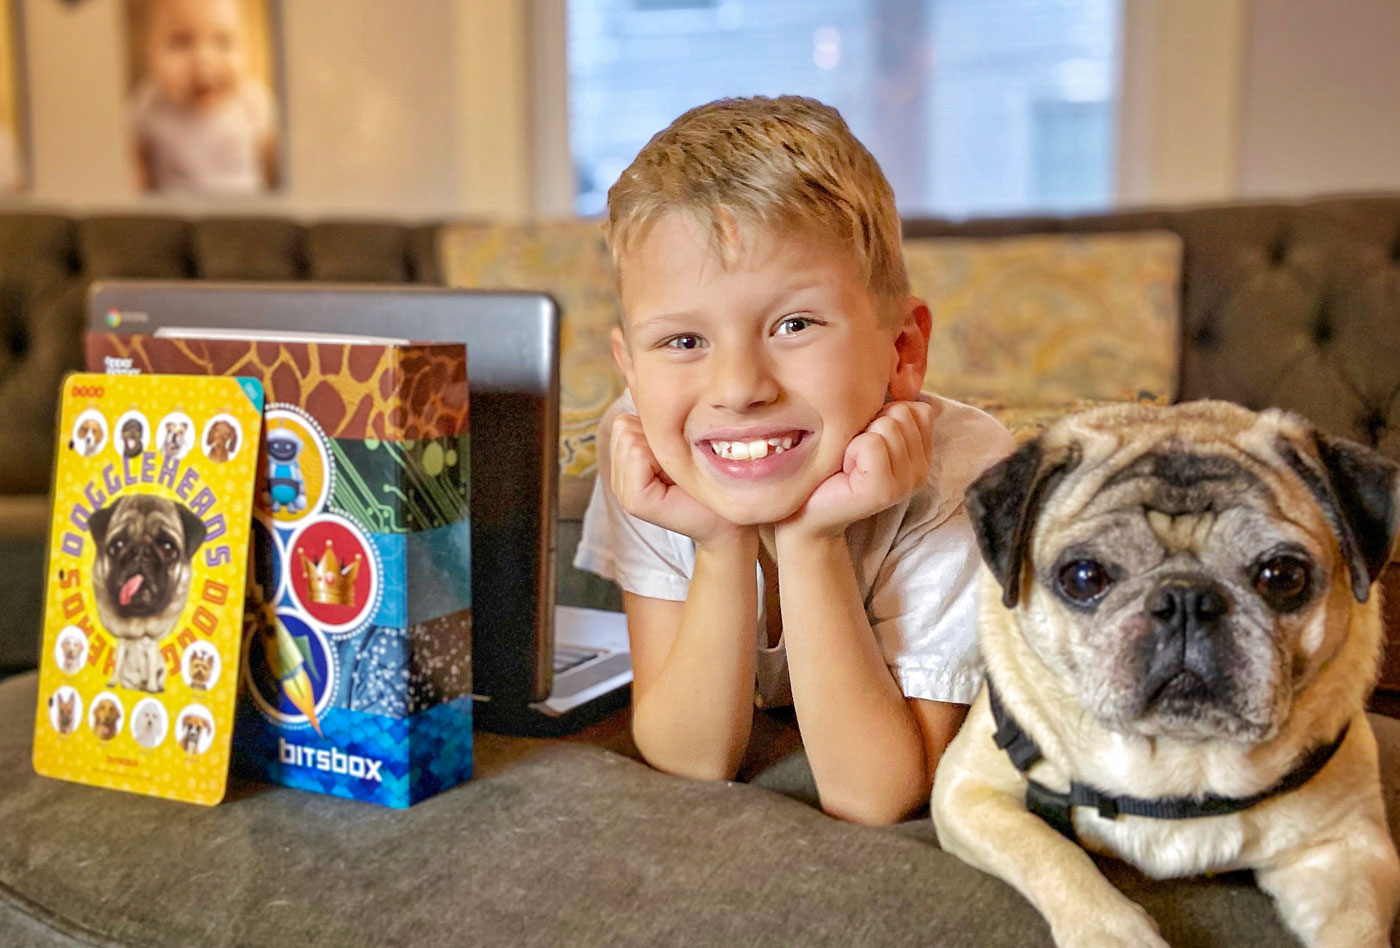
left=613, top=213, right=927, bottom=524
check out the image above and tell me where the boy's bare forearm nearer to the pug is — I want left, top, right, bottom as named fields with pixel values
left=777, top=538, right=937, bottom=823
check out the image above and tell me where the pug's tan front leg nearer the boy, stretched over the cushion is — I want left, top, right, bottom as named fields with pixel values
left=932, top=700, right=1168, bottom=948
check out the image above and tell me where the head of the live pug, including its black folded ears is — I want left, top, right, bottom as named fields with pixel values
left=967, top=403, right=1394, bottom=742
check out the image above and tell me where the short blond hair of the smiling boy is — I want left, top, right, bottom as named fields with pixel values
left=605, top=95, right=909, bottom=312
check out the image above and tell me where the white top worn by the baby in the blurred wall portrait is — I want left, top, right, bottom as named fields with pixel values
left=129, top=78, right=276, bottom=195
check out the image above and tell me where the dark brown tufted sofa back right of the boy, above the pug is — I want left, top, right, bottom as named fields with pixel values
left=906, top=195, right=1400, bottom=461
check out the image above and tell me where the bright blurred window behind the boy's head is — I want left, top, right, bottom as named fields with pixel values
left=567, top=0, right=1121, bottom=216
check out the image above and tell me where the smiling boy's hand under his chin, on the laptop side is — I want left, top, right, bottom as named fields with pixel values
left=610, top=414, right=745, bottom=546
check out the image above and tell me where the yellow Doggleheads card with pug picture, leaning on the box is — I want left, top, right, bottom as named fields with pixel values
left=34, top=374, right=263, bottom=805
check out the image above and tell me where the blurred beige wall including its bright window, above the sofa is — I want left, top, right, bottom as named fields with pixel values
left=0, top=0, right=1400, bottom=220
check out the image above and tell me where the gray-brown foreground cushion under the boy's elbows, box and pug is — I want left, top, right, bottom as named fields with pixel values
left=8, top=675, right=1400, bottom=948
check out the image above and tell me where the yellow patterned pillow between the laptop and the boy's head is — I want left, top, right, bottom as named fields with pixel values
left=438, top=220, right=623, bottom=486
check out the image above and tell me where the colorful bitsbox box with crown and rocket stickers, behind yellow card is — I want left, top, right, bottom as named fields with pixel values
left=87, top=333, right=472, bottom=807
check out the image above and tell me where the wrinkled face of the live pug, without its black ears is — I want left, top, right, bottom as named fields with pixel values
left=1026, top=441, right=1351, bottom=741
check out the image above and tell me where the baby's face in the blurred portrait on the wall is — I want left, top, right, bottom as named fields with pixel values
left=146, top=0, right=244, bottom=112
